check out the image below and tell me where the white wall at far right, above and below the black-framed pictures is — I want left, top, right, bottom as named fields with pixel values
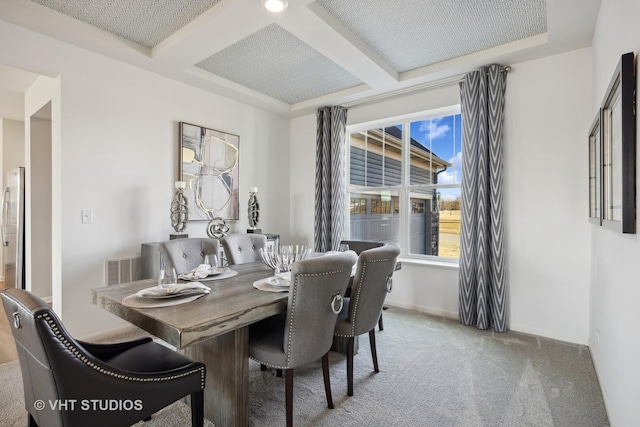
left=589, top=0, right=640, bottom=427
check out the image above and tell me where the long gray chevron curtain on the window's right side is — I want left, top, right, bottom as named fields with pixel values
left=458, top=65, right=507, bottom=332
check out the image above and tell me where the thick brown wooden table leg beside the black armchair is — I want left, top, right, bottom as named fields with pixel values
left=183, top=327, right=249, bottom=427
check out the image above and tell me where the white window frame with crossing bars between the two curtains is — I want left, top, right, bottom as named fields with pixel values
left=344, top=104, right=462, bottom=266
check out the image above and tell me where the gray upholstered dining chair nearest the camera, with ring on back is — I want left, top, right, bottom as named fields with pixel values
left=249, top=251, right=357, bottom=427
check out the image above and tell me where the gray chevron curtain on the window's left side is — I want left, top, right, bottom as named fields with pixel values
left=313, top=107, right=347, bottom=252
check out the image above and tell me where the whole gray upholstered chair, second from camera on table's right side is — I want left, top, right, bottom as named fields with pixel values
left=335, top=244, right=400, bottom=396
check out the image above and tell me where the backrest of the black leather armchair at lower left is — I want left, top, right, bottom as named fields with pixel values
left=1, top=288, right=70, bottom=427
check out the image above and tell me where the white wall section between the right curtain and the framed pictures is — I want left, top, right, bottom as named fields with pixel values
left=504, top=49, right=594, bottom=344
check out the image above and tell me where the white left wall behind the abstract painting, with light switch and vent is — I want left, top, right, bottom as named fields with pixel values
left=0, top=21, right=289, bottom=336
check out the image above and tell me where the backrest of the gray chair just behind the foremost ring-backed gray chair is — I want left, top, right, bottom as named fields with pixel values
left=348, top=244, right=400, bottom=336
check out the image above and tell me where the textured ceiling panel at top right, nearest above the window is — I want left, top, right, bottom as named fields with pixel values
left=317, top=0, right=547, bottom=72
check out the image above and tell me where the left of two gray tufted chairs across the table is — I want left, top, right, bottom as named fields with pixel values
left=160, top=237, right=220, bottom=274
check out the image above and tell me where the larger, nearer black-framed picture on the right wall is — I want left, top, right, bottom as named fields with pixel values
left=601, top=53, right=636, bottom=233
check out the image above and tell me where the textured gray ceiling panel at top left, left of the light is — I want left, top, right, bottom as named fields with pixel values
left=31, top=0, right=220, bottom=48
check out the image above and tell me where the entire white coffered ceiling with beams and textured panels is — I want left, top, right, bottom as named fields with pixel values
left=0, top=0, right=600, bottom=116
